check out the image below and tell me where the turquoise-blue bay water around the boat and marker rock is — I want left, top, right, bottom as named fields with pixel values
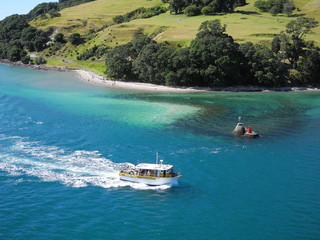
left=0, top=65, right=320, bottom=240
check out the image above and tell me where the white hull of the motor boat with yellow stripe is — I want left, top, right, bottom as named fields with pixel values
left=119, top=174, right=180, bottom=186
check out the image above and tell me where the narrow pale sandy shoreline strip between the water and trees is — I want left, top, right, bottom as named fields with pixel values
left=0, top=59, right=320, bottom=93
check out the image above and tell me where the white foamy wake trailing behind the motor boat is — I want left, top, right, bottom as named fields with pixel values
left=0, top=135, right=170, bottom=190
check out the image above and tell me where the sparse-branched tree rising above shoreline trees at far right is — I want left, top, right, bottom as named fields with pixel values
left=281, top=17, right=318, bottom=69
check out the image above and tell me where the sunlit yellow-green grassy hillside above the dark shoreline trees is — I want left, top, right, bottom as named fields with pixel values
left=31, top=0, right=320, bottom=73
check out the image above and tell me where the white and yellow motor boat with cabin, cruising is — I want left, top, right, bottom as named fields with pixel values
left=119, top=157, right=181, bottom=186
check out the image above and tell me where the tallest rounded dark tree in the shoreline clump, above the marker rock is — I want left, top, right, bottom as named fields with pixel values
left=190, top=20, right=244, bottom=87
